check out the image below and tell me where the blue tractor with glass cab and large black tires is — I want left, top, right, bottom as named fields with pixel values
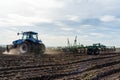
left=7, top=31, right=45, bottom=54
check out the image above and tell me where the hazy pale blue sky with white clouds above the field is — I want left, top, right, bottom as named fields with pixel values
left=0, top=0, right=120, bottom=46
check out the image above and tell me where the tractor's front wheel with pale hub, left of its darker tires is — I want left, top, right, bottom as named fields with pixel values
left=19, top=42, right=30, bottom=54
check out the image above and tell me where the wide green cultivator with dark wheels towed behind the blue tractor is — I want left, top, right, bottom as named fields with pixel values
left=63, top=37, right=115, bottom=55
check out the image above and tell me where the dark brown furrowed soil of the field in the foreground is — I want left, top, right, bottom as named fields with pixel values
left=0, top=53, right=120, bottom=80
